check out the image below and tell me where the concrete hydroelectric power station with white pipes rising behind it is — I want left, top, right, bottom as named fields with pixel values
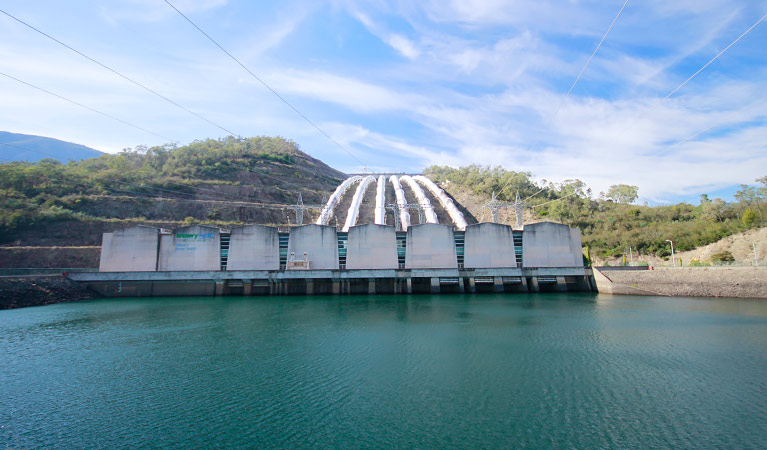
left=68, top=174, right=596, bottom=297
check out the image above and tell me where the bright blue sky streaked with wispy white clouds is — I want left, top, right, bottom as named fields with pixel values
left=0, top=0, right=767, bottom=203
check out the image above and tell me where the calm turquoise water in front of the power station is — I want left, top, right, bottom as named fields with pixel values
left=0, top=294, right=767, bottom=449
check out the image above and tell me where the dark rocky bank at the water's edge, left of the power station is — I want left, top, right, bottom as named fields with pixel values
left=0, top=274, right=100, bottom=309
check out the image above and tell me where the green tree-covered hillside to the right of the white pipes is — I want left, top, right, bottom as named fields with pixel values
left=424, top=166, right=767, bottom=257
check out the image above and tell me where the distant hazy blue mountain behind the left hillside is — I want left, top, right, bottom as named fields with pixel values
left=0, top=131, right=102, bottom=162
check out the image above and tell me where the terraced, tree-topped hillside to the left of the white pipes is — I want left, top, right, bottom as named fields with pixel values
left=0, top=137, right=345, bottom=245
